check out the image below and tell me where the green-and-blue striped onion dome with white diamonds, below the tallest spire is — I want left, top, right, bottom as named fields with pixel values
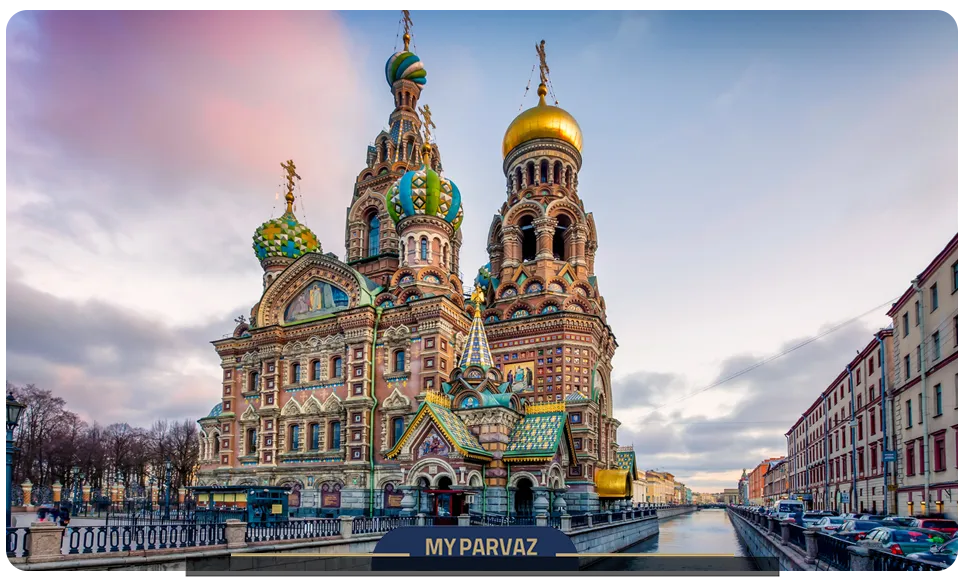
left=385, top=143, right=463, bottom=231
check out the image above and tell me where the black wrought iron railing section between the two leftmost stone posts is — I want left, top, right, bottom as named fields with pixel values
left=64, top=524, right=227, bottom=554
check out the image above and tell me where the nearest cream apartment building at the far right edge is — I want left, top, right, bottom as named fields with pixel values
left=888, top=233, right=961, bottom=519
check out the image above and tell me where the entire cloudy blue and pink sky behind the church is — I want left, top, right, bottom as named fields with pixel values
left=0, top=9, right=960, bottom=491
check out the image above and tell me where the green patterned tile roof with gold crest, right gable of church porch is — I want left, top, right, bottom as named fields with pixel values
left=502, top=403, right=573, bottom=462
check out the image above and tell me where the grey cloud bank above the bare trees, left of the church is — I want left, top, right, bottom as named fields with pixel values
left=2, top=268, right=242, bottom=425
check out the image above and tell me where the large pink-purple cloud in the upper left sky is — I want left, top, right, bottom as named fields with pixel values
left=7, top=10, right=364, bottom=198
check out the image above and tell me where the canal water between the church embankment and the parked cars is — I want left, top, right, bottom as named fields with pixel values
left=586, top=510, right=757, bottom=572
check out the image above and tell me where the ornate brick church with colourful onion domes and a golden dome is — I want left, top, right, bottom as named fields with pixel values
left=198, top=10, right=636, bottom=517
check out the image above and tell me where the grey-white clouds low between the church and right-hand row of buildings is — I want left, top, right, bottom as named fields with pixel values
left=613, top=322, right=873, bottom=491
